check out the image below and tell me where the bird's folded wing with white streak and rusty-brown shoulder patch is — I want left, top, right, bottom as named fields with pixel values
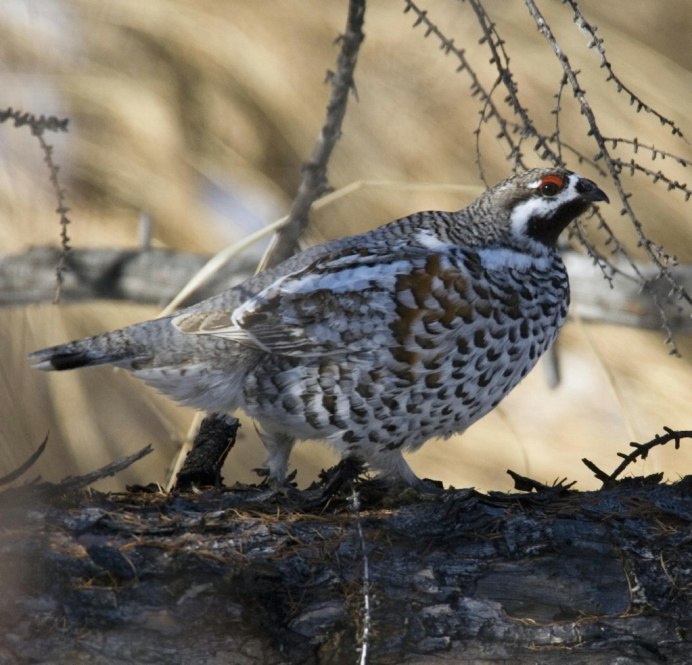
left=173, top=242, right=482, bottom=357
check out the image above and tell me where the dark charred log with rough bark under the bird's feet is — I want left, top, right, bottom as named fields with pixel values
left=0, top=477, right=692, bottom=665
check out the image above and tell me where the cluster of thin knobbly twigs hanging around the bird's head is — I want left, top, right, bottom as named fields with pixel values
left=404, top=0, right=692, bottom=355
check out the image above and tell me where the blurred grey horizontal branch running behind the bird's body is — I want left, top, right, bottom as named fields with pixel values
left=6, top=247, right=692, bottom=332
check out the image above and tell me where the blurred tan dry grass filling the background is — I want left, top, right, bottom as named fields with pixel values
left=0, top=0, right=692, bottom=488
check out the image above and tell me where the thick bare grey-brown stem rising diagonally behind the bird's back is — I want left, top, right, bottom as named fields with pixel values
left=258, top=0, right=365, bottom=270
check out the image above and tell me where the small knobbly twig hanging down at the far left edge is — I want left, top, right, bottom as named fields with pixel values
left=0, top=108, right=70, bottom=303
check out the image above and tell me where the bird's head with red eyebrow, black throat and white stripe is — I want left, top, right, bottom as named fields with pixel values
left=476, top=168, right=608, bottom=246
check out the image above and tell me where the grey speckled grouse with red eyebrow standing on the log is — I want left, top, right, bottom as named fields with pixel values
left=32, top=169, right=608, bottom=484
